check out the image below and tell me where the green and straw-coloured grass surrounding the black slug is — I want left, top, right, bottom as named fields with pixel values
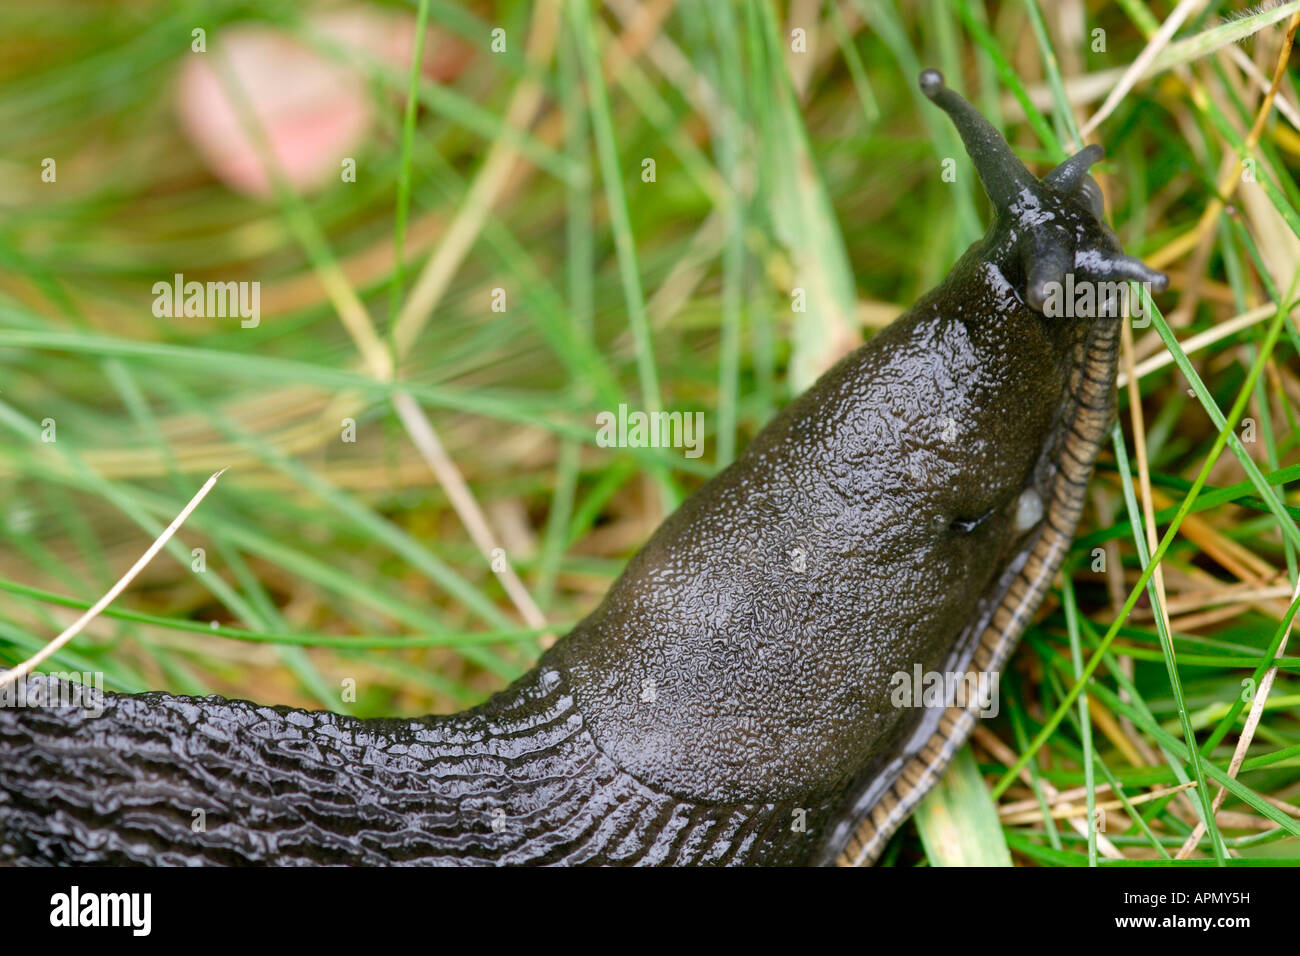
left=0, top=0, right=1300, bottom=866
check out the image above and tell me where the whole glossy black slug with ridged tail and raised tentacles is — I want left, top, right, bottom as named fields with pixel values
left=0, top=70, right=1165, bottom=864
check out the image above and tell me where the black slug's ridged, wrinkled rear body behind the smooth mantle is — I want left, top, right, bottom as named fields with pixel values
left=0, top=667, right=809, bottom=866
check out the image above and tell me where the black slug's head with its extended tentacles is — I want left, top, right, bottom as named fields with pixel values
left=920, top=69, right=1169, bottom=312
